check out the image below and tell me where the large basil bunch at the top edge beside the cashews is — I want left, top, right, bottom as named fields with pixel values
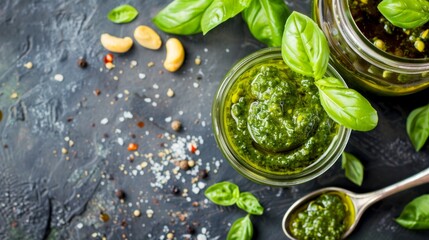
left=153, top=0, right=289, bottom=47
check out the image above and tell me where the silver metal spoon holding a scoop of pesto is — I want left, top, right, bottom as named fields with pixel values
left=282, top=168, right=429, bottom=239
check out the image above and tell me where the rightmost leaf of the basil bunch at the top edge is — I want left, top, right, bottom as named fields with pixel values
left=242, top=0, right=290, bottom=47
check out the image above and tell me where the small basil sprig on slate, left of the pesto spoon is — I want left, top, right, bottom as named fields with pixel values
left=204, top=181, right=264, bottom=240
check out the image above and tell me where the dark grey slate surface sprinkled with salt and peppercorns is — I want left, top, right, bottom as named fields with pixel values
left=0, top=0, right=429, bottom=239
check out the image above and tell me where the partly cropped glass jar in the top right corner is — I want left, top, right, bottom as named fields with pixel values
left=313, top=0, right=429, bottom=96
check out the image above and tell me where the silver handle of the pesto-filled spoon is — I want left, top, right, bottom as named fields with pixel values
left=361, top=168, right=429, bottom=208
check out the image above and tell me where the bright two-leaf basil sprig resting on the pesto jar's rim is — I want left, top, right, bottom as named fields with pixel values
left=281, top=12, right=378, bottom=131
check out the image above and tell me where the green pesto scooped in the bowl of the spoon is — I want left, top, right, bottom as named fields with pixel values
left=289, top=194, right=348, bottom=240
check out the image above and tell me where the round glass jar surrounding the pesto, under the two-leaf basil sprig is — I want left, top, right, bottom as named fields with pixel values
left=212, top=48, right=351, bottom=187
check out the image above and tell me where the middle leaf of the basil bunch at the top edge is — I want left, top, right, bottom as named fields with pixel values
left=201, top=0, right=251, bottom=34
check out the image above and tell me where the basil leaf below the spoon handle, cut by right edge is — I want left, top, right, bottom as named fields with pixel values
left=395, top=194, right=429, bottom=229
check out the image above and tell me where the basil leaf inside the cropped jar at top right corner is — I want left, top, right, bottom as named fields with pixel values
left=377, top=0, right=429, bottom=28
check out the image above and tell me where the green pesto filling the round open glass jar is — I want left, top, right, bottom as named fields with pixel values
left=224, top=60, right=339, bottom=175
